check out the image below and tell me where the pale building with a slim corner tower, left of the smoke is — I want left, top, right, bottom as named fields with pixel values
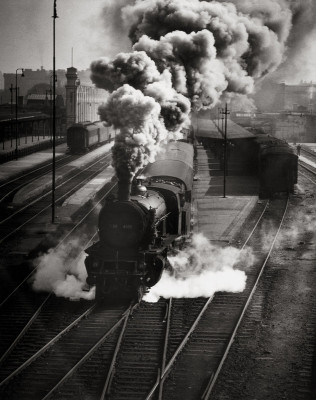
left=66, top=67, right=106, bottom=127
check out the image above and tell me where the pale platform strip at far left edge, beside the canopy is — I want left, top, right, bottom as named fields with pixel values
left=0, top=143, right=67, bottom=184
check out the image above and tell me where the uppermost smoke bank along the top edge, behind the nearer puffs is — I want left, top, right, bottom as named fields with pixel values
left=124, top=0, right=291, bottom=78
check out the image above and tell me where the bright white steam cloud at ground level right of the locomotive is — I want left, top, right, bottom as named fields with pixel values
left=144, top=234, right=254, bottom=302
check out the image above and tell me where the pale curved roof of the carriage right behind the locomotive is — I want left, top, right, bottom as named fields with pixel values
left=143, top=142, right=194, bottom=190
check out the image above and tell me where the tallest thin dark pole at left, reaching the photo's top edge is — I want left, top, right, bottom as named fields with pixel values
left=52, top=0, right=58, bottom=224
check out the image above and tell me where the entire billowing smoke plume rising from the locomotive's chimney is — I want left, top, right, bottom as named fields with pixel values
left=91, top=0, right=291, bottom=179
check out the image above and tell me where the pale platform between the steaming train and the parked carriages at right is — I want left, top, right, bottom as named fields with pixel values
left=193, top=146, right=259, bottom=243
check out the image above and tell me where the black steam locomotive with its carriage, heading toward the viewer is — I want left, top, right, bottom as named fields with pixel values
left=85, top=142, right=193, bottom=299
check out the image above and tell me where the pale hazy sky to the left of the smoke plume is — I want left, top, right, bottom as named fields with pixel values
left=0, top=0, right=128, bottom=72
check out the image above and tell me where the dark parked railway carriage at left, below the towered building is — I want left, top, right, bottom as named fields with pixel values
left=67, top=121, right=115, bottom=154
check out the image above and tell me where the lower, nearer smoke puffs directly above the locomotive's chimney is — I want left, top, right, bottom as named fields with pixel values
left=91, top=51, right=190, bottom=180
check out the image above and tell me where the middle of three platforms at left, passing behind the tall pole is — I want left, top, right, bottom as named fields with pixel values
left=12, top=142, right=113, bottom=206
